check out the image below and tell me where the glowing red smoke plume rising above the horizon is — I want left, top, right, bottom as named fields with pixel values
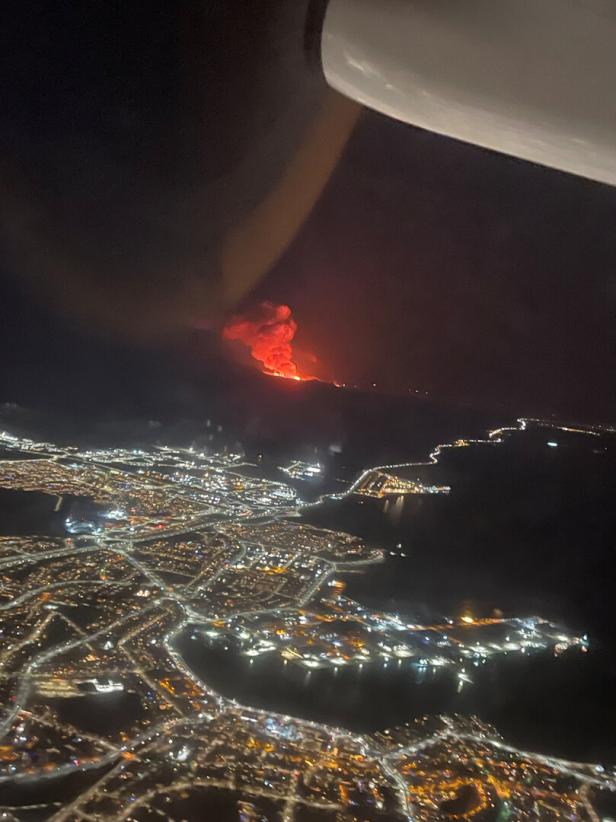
left=222, top=302, right=306, bottom=380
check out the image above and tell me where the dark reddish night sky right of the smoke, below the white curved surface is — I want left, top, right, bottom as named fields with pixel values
left=264, top=114, right=616, bottom=417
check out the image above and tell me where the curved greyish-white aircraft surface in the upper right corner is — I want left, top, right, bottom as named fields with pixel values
left=322, top=0, right=616, bottom=185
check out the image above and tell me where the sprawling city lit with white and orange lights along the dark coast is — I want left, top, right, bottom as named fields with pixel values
left=0, top=420, right=616, bottom=822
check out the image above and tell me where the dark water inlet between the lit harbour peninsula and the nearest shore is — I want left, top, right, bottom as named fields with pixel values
left=177, top=629, right=616, bottom=760
